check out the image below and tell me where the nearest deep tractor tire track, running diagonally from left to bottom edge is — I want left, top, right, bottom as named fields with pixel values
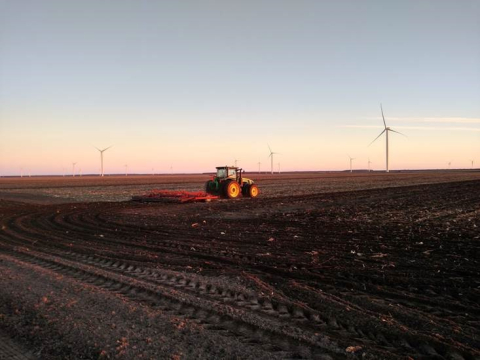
left=0, top=250, right=352, bottom=360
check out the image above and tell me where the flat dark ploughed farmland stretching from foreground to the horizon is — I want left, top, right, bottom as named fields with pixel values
left=0, top=171, right=480, bottom=360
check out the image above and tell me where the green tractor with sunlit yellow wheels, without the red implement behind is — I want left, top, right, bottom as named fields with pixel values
left=205, top=166, right=259, bottom=199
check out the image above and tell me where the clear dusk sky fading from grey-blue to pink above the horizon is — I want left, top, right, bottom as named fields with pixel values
left=0, top=0, right=480, bottom=176
